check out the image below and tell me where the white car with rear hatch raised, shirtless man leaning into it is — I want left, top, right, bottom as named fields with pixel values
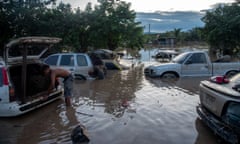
left=0, top=37, right=63, bottom=117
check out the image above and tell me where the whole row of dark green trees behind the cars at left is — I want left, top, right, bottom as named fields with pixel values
left=0, top=0, right=143, bottom=52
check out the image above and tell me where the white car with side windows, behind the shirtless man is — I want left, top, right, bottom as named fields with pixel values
left=44, top=53, right=93, bottom=80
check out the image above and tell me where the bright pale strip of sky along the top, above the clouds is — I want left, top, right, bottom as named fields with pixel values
left=62, top=0, right=234, bottom=12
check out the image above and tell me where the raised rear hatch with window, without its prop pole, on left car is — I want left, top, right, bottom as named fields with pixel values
left=4, top=37, right=61, bottom=63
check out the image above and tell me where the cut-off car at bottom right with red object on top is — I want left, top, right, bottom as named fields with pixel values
left=197, top=74, right=240, bottom=144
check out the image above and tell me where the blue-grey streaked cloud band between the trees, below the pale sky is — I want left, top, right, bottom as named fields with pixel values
left=136, top=11, right=204, bottom=33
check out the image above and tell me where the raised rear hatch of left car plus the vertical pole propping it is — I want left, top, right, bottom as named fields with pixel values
left=4, top=37, right=61, bottom=103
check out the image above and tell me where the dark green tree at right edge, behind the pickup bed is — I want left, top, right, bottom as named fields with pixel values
left=202, top=3, right=240, bottom=55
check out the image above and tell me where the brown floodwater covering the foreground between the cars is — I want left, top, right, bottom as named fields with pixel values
left=0, top=62, right=221, bottom=144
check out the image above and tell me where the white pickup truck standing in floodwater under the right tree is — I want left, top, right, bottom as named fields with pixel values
left=144, top=51, right=240, bottom=78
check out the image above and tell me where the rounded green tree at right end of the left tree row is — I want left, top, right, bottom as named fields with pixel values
left=91, top=0, right=143, bottom=50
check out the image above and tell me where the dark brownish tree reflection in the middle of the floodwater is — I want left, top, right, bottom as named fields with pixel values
left=74, top=67, right=143, bottom=118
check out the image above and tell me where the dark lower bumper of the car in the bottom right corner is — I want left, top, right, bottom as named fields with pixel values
left=196, top=104, right=239, bottom=144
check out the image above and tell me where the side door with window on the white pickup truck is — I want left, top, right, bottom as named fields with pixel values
left=181, top=53, right=210, bottom=76
